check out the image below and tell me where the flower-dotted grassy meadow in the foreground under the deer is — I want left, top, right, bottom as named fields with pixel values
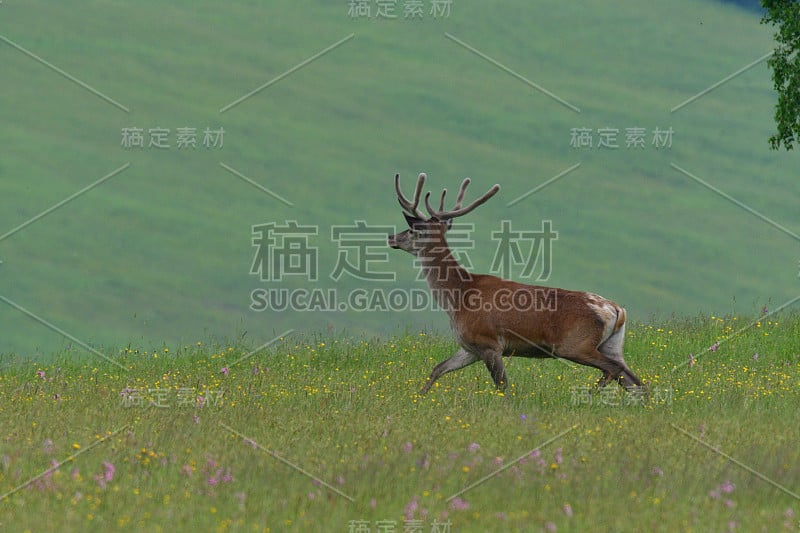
left=0, top=314, right=800, bottom=532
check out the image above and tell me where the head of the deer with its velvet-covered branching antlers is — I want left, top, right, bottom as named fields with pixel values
left=389, top=173, right=500, bottom=257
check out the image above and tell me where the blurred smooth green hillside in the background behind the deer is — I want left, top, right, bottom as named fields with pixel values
left=0, top=0, right=800, bottom=355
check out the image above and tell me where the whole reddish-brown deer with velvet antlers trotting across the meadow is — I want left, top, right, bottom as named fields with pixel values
left=388, top=173, right=644, bottom=395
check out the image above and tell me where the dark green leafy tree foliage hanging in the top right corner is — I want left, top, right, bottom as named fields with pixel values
left=761, top=0, right=800, bottom=150
